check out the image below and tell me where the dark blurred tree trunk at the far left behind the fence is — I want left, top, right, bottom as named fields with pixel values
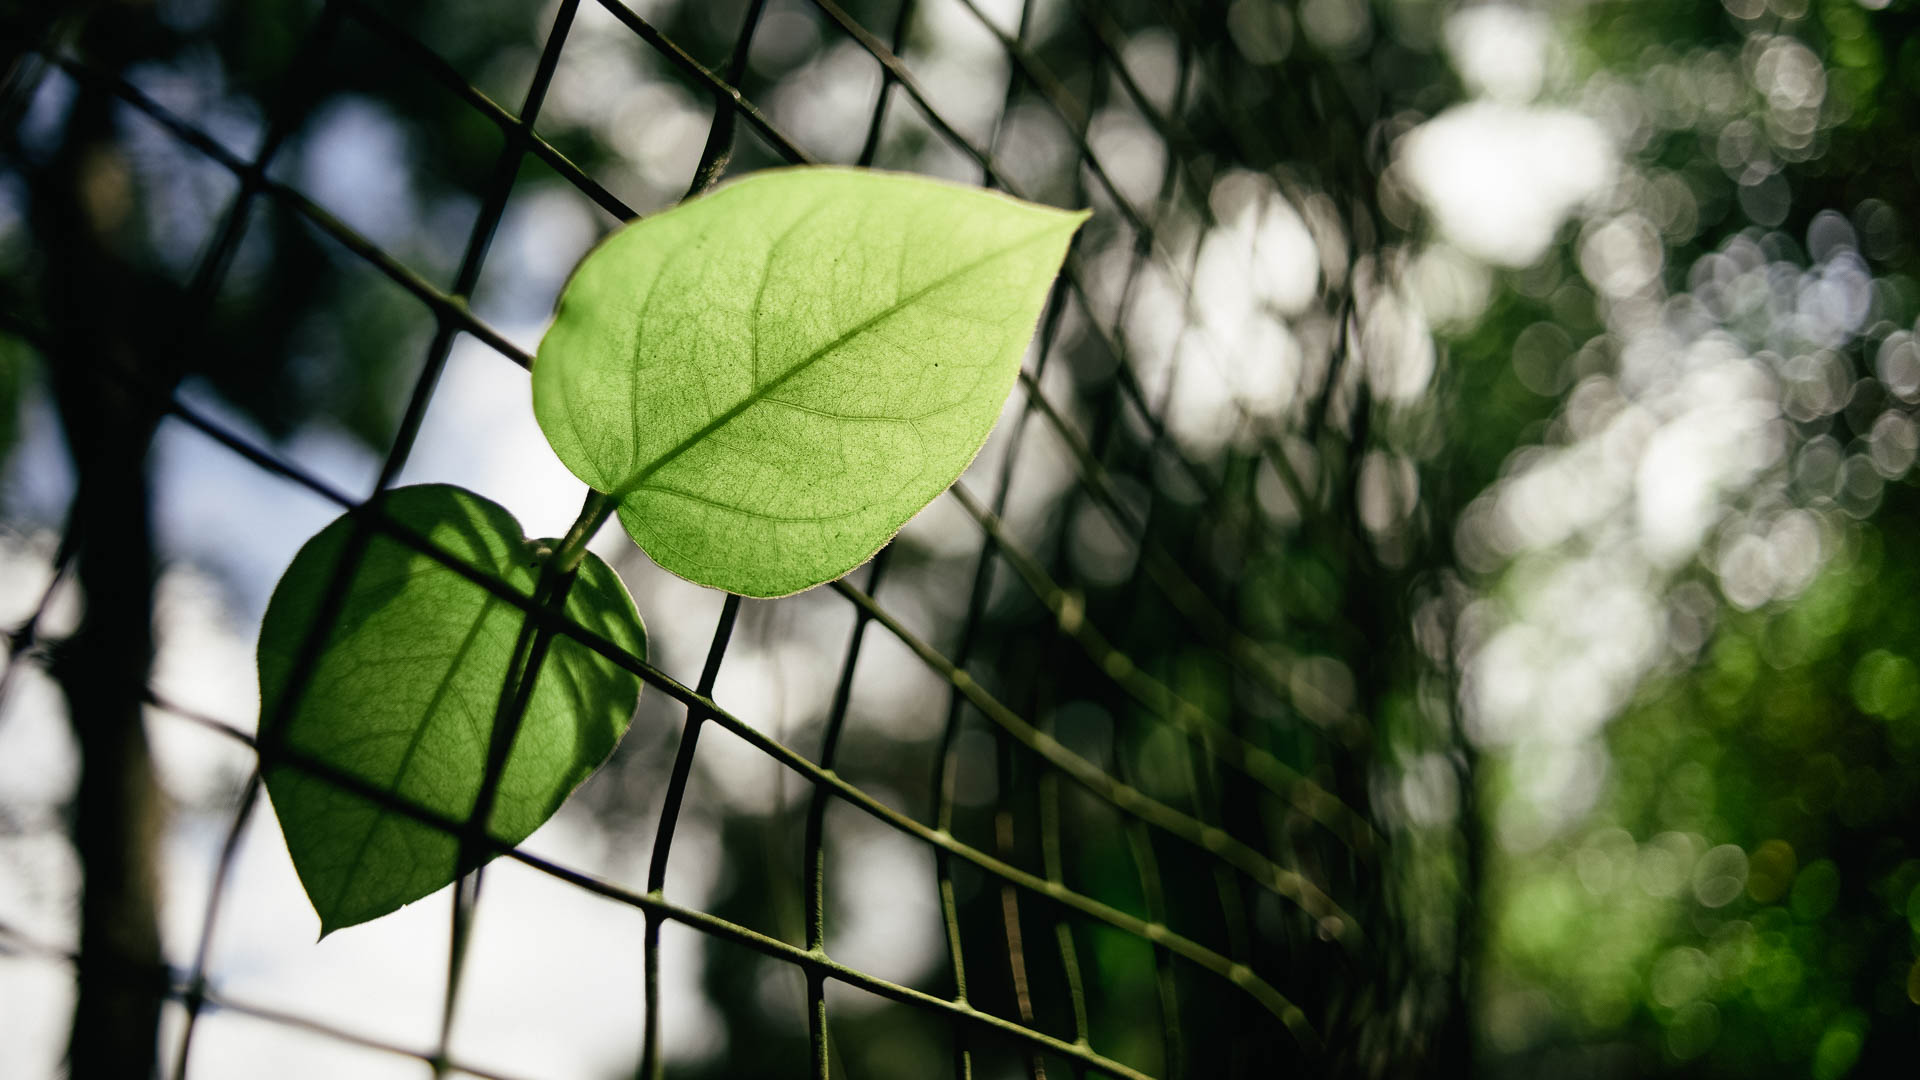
left=33, top=4, right=175, bottom=1080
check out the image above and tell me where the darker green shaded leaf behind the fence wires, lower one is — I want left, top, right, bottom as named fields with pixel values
left=259, top=484, right=647, bottom=934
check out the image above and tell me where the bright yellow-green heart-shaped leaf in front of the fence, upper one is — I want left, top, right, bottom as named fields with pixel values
left=534, top=169, right=1087, bottom=596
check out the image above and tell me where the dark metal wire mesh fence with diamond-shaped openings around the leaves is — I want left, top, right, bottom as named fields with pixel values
left=0, top=0, right=1455, bottom=1080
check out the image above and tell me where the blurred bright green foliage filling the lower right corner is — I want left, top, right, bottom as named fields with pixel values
left=1488, top=486, right=1920, bottom=1076
